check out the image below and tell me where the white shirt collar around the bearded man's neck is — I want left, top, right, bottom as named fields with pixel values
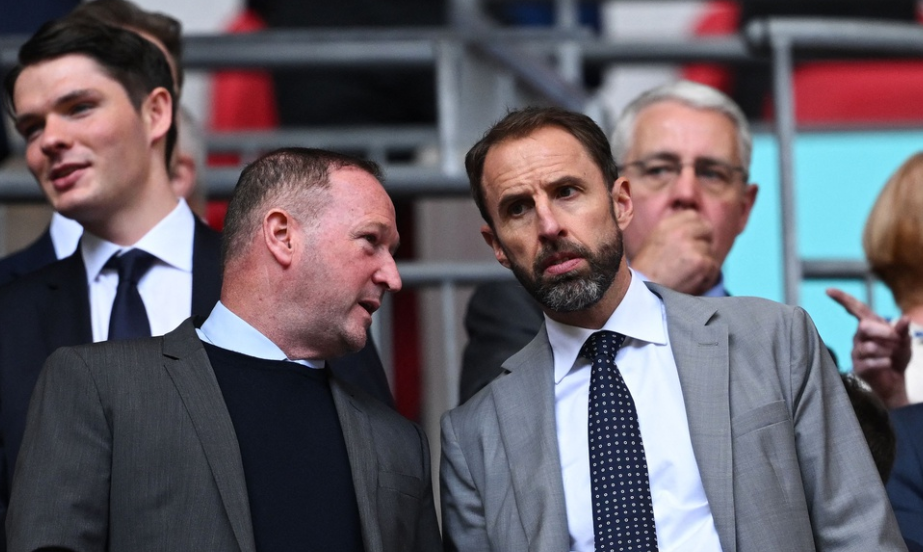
left=545, top=271, right=667, bottom=384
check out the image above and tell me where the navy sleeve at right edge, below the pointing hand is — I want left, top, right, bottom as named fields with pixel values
left=887, top=406, right=923, bottom=542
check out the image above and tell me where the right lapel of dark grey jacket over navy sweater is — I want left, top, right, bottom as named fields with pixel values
left=330, top=378, right=382, bottom=552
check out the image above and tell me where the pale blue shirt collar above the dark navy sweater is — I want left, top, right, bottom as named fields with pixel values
left=196, top=301, right=324, bottom=368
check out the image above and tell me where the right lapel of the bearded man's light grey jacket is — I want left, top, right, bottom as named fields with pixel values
left=649, top=284, right=737, bottom=552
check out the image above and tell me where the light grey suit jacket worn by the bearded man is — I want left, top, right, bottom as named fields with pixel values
left=441, top=284, right=905, bottom=552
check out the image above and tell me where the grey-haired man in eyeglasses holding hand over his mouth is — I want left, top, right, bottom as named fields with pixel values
left=459, top=81, right=758, bottom=402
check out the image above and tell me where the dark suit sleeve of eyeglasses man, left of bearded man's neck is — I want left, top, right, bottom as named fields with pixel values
left=459, top=282, right=544, bottom=403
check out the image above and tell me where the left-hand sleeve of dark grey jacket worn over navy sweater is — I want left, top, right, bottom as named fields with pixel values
left=6, top=349, right=112, bottom=552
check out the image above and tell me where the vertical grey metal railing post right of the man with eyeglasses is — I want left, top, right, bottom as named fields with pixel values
left=770, top=37, right=801, bottom=305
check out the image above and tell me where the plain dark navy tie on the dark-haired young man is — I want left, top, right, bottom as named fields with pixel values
left=105, top=249, right=154, bottom=339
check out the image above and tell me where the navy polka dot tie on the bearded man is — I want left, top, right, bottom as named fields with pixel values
left=580, top=331, right=657, bottom=552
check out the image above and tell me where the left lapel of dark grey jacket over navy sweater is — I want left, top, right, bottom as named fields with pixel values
left=163, top=319, right=256, bottom=552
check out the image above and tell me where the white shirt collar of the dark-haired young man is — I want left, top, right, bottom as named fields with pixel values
left=80, top=199, right=195, bottom=282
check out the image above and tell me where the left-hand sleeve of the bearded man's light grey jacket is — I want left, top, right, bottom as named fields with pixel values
left=439, top=412, right=490, bottom=552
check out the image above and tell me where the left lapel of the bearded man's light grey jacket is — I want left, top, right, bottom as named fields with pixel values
left=498, top=325, right=569, bottom=550
